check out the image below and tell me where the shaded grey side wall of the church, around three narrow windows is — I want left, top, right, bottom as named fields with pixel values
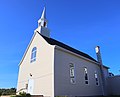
left=54, top=48, right=102, bottom=96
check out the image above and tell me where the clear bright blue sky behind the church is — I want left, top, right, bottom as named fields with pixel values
left=0, top=0, right=120, bottom=88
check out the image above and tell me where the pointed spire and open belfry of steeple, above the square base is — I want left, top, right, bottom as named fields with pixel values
left=38, top=7, right=47, bottom=27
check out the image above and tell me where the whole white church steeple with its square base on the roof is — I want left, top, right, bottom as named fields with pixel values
left=35, top=7, right=50, bottom=38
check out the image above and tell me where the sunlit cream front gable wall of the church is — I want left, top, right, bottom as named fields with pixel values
left=17, top=32, right=54, bottom=97
